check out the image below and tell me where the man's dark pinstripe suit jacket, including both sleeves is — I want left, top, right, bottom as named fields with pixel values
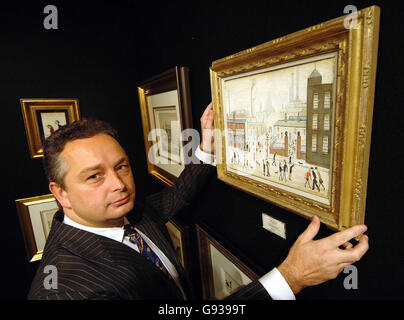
left=28, top=164, right=268, bottom=300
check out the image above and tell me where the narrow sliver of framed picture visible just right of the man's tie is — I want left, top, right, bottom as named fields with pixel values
left=166, top=218, right=190, bottom=273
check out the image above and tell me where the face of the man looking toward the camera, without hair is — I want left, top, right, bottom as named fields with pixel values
left=57, top=134, right=136, bottom=227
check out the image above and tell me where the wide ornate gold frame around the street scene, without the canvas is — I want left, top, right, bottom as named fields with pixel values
left=210, top=6, right=380, bottom=230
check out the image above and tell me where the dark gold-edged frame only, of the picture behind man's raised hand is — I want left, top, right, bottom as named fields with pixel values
left=138, top=66, right=192, bottom=186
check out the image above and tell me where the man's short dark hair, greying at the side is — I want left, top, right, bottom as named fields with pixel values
left=43, top=119, right=118, bottom=188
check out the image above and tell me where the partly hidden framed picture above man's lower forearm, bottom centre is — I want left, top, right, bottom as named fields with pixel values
left=196, top=225, right=259, bottom=300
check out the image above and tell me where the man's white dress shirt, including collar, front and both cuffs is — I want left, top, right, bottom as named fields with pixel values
left=63, top=146, right=296, bottom=300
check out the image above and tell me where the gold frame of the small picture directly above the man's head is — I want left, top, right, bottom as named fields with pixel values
left=20, top=99, right=80, bottom=159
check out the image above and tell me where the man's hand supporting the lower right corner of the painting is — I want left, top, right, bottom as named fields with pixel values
left=278, top=216, right=369, bottom=294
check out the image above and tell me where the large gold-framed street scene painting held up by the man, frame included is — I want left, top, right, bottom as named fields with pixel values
left=210, top=6, right=380, bottom=230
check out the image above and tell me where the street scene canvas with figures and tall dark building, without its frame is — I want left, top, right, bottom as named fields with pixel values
left=222, top=53, right=336, bottom=204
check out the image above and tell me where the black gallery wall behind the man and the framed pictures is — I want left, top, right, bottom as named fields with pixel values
left=0, top=0, right=404, bottom=300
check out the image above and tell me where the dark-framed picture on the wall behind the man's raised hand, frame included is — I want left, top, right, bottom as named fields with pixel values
left=138, top=67, right=192, bottom=186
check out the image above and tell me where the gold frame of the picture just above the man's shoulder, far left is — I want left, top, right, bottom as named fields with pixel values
left=15, top=194, right=56, bottom=262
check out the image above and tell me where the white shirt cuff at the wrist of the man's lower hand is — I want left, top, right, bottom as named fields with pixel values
left=258, top=268, right=296, bottom=300
